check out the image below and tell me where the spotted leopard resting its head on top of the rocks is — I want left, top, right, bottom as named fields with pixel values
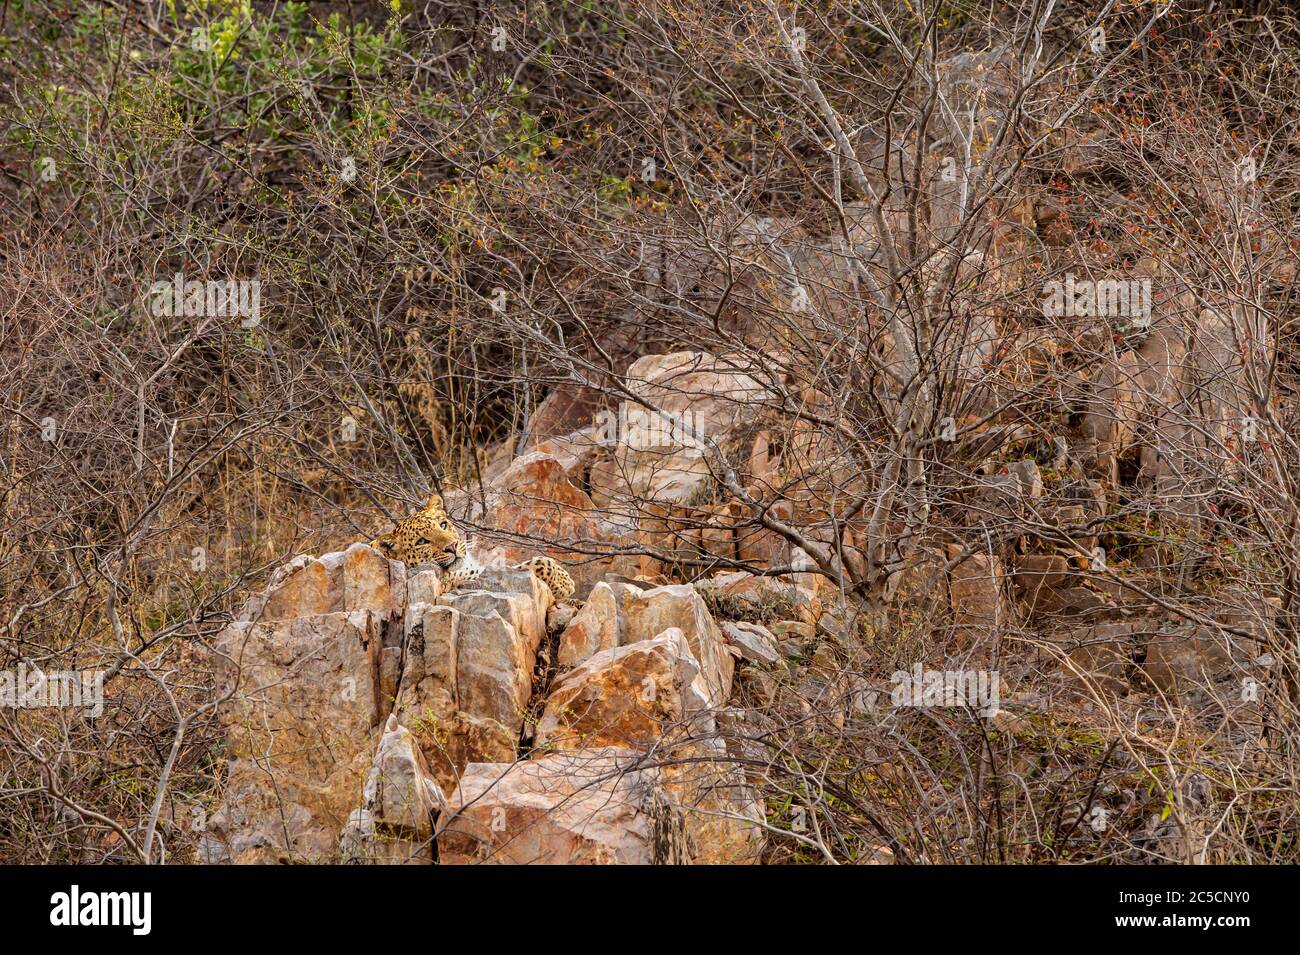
left=371, top=494, right=577, bottom=604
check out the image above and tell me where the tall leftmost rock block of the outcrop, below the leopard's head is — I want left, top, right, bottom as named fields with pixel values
left=200, top=544, right=406, bottom=863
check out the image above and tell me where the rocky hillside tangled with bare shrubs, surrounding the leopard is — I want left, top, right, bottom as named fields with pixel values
left=0, top=0, right=1300, bottom=864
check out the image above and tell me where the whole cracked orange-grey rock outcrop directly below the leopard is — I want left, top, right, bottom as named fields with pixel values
left=200, top=544, right=762, bottom=864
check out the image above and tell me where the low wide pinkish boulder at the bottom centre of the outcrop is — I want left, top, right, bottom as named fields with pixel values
left=438, top=748, right=692, bottom=865
